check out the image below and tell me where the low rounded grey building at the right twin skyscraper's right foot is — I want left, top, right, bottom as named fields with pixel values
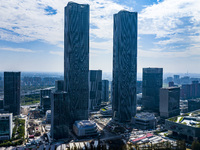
left=132, top=112, right=156, bottom=130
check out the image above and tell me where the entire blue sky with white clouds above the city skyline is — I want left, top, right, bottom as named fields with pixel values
left=0, top=0, right=200, bottom=73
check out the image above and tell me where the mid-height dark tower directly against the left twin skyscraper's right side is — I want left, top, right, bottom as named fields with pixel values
left=89, top=70, right=102, bottom=110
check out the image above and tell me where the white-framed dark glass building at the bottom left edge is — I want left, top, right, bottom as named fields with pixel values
left=0, top=113, right=13, bottom=141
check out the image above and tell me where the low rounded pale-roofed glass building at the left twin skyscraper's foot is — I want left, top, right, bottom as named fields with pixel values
left=73, top=120, right=97, bottom=136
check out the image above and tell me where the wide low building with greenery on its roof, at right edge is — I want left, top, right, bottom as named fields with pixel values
left=165, top=109, right=200, bottom=141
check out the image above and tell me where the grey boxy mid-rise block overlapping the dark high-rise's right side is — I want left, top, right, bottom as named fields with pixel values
left=160, top=87, right=180, bottom=118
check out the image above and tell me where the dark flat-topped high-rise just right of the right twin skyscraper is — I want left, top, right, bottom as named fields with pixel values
left=142, top=68, right=163, bottom=112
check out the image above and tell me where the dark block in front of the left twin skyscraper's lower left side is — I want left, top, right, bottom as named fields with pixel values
left=51, top=92, right=70, bottom=139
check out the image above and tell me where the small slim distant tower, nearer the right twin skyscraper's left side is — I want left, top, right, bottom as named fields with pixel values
left=102, top=80, right=109, bottom=102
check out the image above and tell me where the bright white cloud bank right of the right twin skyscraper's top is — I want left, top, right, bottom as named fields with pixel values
left=139, top=0, right=200, bottom=42
